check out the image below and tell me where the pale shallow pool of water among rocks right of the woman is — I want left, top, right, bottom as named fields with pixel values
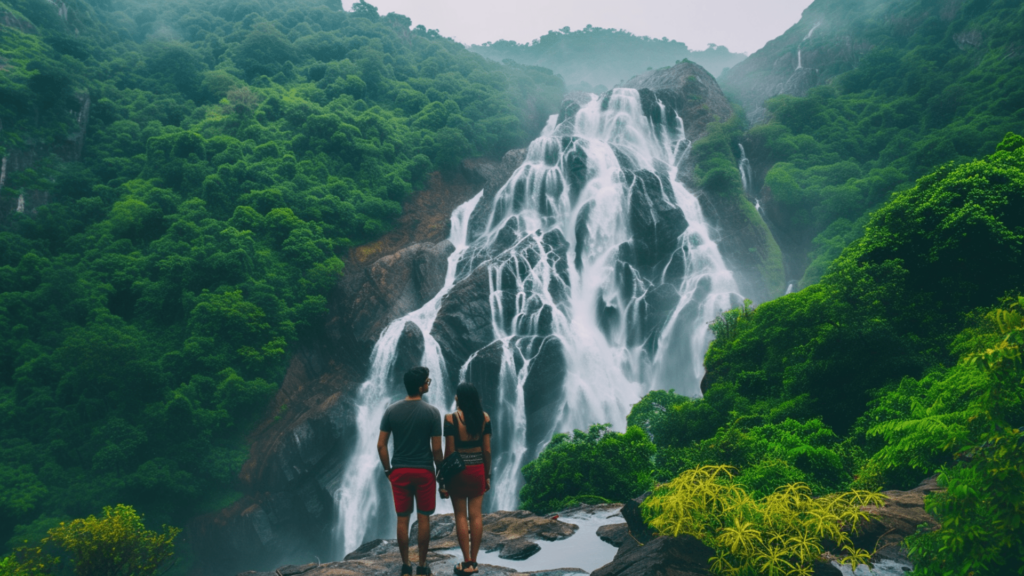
left=449, top=508, right=618, bottom=576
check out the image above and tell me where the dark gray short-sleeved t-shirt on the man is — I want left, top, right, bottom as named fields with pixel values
left=381, top=400, right=441, bottom=471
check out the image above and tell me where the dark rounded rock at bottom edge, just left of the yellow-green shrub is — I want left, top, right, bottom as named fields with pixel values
left=592, top=536, right=715, bottom=576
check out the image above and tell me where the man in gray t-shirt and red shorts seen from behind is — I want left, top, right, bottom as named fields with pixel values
left=377, top=366, right=441, bottom=575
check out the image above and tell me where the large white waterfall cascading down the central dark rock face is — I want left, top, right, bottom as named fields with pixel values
left=337, top=88, right=742, bottom=552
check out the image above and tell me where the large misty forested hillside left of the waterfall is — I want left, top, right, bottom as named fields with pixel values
left=0, top=0, right=563, bottom=542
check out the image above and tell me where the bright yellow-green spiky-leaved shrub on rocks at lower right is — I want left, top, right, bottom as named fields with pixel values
left=643, top=465, right=885, bottom=576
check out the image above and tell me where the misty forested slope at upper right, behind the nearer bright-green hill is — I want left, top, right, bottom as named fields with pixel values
left=744, top=0, right=1024, bottom=286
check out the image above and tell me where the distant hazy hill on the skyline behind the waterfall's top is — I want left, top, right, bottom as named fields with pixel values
left=469, top=26, right=746, bottom=92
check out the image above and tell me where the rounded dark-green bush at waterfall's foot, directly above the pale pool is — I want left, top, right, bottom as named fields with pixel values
left=519, top=424, right=654, bottom=513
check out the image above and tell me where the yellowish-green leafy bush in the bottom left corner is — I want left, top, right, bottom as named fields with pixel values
left=0, top=504, right=181, bottom=576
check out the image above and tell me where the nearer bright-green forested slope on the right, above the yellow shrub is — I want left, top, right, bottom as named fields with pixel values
left=523, top=134, right=1024, bottom=574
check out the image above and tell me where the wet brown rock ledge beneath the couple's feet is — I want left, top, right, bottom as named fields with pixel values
left=239, top=510, right=586, bottom=576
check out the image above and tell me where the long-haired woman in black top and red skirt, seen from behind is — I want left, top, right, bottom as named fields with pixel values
left=440, top=383, right=490, bottom=576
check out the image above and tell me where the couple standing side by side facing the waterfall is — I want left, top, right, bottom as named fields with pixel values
left=377, top=366, right=490, bottom=576
